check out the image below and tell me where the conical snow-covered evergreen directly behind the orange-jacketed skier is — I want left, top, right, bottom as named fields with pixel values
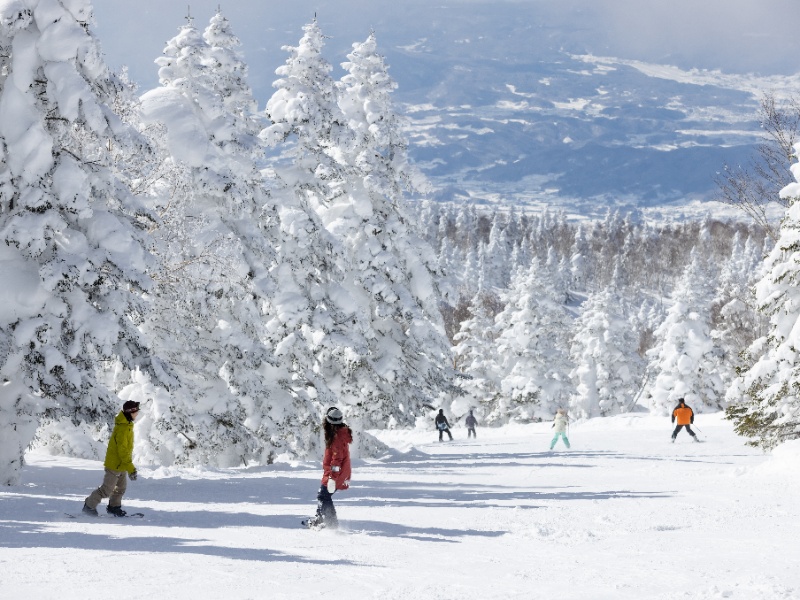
left=648, top=251, right=725, bottom=414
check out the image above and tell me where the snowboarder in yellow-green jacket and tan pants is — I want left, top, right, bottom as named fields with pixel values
left=83, top=400, right=139, bottom=517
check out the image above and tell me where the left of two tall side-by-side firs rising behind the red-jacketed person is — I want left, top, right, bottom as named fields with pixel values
left=260, top=22, right=394, bottom=426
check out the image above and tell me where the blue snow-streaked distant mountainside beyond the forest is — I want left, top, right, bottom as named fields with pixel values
left=398, top=54, right=758, bottom=212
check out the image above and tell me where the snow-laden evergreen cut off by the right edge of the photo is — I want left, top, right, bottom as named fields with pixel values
left=726, top=145, right=800, bottom=450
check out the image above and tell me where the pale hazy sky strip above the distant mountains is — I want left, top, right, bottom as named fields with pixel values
left=90, top=0, right=800, bottom=102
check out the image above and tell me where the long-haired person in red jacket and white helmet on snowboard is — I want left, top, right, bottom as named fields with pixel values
left=303, top=406, right=353, bottom=529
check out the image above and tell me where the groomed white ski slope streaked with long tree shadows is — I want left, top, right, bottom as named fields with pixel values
left=0, top=414, right=800, bottom=600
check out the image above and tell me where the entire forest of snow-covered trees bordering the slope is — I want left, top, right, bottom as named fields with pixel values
left=0, top=0, right=800, bottom=484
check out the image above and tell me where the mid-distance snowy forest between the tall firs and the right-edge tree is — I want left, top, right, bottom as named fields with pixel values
left=410, top=203, right=771, bottom=422
